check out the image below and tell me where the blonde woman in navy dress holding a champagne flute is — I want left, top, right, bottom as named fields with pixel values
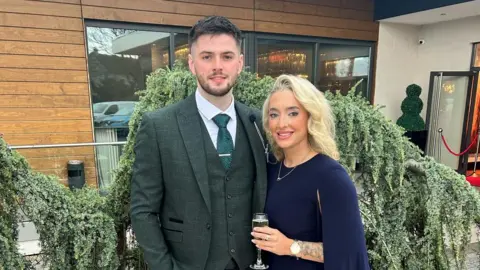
left=252, top=75, right=370, bottom=270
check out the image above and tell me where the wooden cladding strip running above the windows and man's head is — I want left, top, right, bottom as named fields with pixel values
left=82, top=0, right=378, bottom=41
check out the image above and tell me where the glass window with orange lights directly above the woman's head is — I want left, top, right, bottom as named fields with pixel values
left=257, top=39, right=314, bottom=81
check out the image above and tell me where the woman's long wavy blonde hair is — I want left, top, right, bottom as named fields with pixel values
left=263, top=74, right=340, bottom=161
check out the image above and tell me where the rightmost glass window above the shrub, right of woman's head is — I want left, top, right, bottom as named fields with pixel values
left=315, top=44, right=370, bottom=94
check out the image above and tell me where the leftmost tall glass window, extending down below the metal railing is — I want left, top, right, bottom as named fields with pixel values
left=86, top=26, right=170, bottom=190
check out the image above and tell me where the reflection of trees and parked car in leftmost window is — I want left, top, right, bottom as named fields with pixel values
left=87, top=27, right=170, bottom=127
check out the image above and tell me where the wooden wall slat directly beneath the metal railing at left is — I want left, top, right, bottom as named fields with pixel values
left=17, top=146, right=94, bottom=158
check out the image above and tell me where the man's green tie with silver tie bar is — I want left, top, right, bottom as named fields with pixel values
left=213, top=113, right=233, bottom=169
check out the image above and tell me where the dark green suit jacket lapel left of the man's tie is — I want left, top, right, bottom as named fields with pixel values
left=177, top=94, right=212, bottom=213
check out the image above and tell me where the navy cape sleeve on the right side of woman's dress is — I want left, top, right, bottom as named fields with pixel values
left=318, top=168, right=370, bottom=270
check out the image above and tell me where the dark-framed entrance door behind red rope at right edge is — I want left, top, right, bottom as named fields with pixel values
left=426, top=71, right=478, bottom=173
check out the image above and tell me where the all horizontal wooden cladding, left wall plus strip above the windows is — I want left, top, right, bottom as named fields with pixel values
left=0, top=0, right=378, bottom=188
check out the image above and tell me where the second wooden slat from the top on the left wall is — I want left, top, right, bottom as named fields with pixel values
left=0, top=12, right=83, bottom=31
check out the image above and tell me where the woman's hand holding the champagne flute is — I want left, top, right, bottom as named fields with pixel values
left=252, top=227, right=293, bottom=256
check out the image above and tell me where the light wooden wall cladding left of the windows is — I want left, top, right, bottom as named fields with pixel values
left=0, top=0, right=97, bottom=185
